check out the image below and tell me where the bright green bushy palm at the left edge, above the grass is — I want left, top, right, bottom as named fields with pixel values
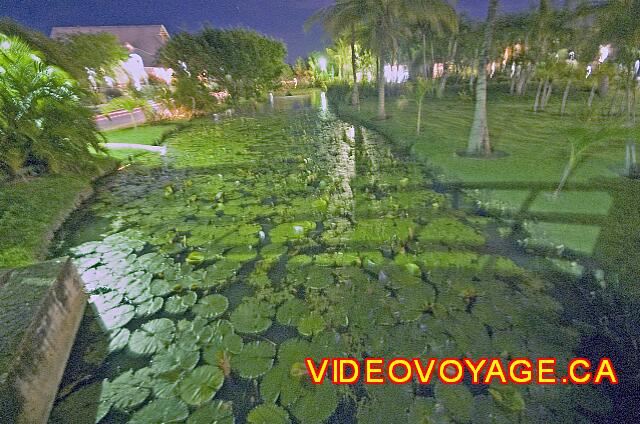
left=0, top=34, right=100, bottom=178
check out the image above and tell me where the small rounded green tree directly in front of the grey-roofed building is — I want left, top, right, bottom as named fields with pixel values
left=62, top=32, right=128, bottom=79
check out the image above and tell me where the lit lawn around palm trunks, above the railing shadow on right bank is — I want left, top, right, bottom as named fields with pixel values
left=346, top=95, right=624, bottom=188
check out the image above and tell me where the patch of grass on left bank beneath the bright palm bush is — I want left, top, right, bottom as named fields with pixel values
left=0, top=158, right=114, bottom=268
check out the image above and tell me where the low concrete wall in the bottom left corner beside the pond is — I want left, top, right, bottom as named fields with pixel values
left=0, top=259, right=87, bottom=424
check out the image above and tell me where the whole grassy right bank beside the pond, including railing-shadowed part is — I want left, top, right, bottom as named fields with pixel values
left=334, top=88, right=640, bottom=291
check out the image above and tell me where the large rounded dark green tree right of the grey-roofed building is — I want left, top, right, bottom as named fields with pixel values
left=159, top=27, right=287, bottom=100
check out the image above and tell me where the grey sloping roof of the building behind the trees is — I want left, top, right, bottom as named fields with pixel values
left=51, top=25, right=169, bottom=66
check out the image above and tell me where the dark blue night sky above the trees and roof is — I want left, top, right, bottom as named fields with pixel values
left=0, top=0, right=532, bottom=60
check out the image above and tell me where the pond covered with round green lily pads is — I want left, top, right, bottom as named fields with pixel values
left=51, top=99, right=577, bottom=424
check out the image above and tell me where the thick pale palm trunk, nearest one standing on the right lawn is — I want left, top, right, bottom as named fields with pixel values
left=467, top=0, right=498, bottom=156
